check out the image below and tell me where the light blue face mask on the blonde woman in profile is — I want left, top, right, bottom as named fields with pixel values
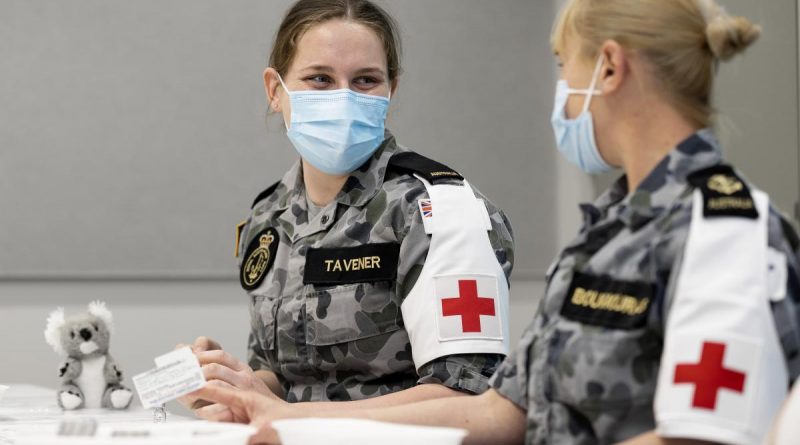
left=551, top=57, right=614, bottom=174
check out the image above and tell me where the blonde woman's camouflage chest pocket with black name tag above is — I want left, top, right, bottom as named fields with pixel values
left=548, top=272, right=662, bottom=418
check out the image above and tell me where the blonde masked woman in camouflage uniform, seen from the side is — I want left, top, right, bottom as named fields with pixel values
left=192, top=0, right=800, bottom=445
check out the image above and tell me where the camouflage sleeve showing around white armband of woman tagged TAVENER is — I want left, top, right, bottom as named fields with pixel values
left=397, top=183, right=514, bottom=394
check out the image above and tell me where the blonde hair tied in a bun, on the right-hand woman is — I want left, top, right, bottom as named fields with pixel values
left=552, top=0, right=761, bottom=127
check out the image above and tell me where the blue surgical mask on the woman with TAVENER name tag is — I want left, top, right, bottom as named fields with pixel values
left=278, top=76, right=391, bottom=176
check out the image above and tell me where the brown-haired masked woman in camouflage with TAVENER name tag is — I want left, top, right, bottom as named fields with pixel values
left=181, top=0, right=513, bottom=417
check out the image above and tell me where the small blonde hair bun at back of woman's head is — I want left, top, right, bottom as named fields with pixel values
left=706, top=14, right=761, bottom=60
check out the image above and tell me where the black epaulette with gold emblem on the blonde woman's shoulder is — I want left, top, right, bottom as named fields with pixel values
left=688, top=164, right=758, bottom=219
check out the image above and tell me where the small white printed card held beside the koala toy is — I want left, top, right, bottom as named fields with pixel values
left=133, top=348, right=206, bottom=408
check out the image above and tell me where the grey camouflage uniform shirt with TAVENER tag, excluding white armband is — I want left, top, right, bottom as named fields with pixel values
left=237, top=133, right=514, bottom=402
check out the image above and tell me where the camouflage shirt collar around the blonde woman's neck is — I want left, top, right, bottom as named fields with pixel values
left=581, top=129, right=722, bottom=230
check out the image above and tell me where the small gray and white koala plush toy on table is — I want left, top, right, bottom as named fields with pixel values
left=44, top=301, right=133, bottom=410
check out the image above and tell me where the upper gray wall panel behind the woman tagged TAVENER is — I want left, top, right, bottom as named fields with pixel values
left=0, top=0, right=556, bottom=279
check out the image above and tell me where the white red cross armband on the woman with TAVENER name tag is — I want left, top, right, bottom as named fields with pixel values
left=401, top=175, right=508, bottom=369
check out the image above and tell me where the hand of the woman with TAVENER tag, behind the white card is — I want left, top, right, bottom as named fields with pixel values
left=177, top=337, right=274, bottom=418
